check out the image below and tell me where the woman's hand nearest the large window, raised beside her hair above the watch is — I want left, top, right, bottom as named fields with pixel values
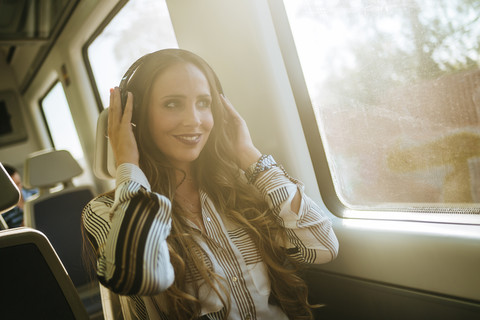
left=220, top=95, right=262, bottom=170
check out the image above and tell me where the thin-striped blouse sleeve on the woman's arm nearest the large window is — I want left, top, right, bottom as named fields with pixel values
left=255, top=167, right=338, bottom=263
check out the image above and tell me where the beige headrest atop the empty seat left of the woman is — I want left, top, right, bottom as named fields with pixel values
left=23, top=150, right=83, bottom=188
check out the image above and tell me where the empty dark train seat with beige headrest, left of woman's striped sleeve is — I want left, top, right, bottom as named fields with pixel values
left=24, top=150, right=101, bottom=314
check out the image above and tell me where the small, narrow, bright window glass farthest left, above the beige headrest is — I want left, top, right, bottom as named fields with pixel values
left=40, top=82, right=92, bottom=184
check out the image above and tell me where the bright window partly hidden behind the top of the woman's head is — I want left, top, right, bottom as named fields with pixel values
left=85, top=0, right=178, bottom=107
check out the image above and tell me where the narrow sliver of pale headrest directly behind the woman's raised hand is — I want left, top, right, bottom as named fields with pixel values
left=93, top=108, right=116, bottom=180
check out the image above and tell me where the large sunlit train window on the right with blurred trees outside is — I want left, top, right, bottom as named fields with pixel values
left=284, top=0, right=480, bottom=213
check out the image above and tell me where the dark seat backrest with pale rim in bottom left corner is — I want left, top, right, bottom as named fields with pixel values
left=0, top=228, right=89, bottom=319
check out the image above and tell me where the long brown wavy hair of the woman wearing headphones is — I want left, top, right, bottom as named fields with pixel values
left=98, top=49, right=312, bottom=319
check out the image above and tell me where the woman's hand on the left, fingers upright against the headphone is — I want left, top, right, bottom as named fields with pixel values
left=108, top=87, right=139, bottom=166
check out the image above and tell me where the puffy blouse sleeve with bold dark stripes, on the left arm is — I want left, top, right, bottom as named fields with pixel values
left=82, top=164, right=174, bottom=295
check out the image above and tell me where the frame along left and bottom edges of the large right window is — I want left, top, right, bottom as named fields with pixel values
left=268, top=0, right=480, bottom=225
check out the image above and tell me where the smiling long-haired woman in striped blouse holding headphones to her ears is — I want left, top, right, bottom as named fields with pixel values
left=83, top=49, right=338, bottom=319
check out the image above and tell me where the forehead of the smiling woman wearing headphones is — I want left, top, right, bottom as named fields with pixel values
left=153, top=62, right=210, bottom=93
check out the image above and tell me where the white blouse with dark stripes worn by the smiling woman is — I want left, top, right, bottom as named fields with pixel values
left=83, top=164, right=338, bottom=319
